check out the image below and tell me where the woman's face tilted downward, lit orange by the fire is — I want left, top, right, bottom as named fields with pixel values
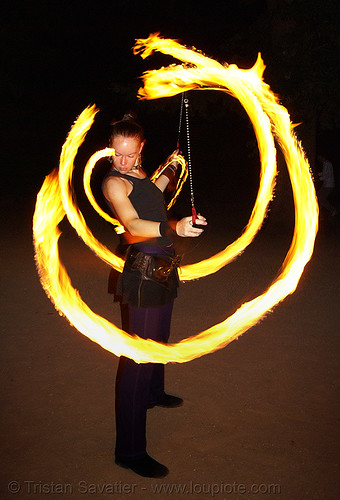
left=111, top=135, right=144, bottom=174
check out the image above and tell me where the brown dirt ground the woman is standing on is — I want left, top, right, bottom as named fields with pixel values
left=0, top=192, right=340, bottom=500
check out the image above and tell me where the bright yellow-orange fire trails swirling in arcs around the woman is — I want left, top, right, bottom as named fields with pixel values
left=33, top=34, right=318, bottom=363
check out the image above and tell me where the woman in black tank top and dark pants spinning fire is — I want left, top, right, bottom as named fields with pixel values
left=103, top=115, right=207, bottom=477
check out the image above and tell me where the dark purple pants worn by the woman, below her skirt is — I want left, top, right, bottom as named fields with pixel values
left=115, top=301, right=173, bottom=459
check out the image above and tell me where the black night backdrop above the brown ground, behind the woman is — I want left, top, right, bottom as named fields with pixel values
left=1, top=0, right=339, bottom=222
